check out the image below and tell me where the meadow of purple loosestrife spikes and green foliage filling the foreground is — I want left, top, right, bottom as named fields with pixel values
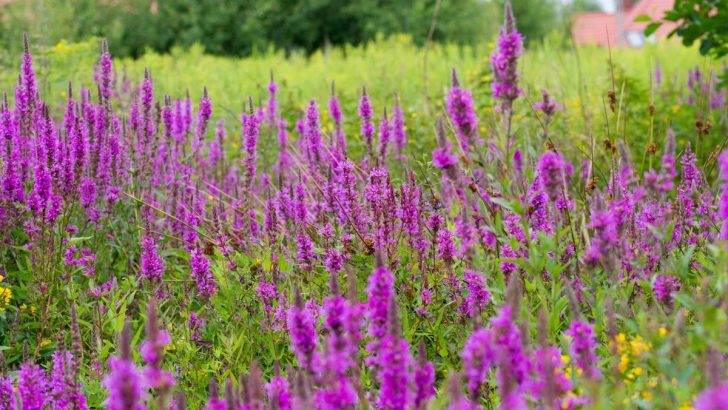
left=0, top=6, right=728, bottom=410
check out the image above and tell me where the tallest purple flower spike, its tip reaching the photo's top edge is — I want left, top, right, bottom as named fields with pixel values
left=490, top=1, right=523, bottom=111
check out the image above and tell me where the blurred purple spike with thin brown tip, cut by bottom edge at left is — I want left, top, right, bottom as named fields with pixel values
left=102, top=323, right=146, bottom=410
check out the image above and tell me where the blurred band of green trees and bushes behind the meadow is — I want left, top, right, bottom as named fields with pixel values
left=0, top=0, right=598, bottom=62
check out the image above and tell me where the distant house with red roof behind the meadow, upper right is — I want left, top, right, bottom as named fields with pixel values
left=571, top=0, right=675, bottom=47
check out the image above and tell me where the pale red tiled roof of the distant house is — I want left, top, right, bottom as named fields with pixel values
left=571, top=0, right=675, bottom=46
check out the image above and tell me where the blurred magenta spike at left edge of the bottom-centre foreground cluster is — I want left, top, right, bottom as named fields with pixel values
left=288, top=289, right=318, bottom=373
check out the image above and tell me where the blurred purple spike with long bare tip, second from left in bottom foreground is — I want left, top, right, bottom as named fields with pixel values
left=139, top=298, right=174, bottom=396
